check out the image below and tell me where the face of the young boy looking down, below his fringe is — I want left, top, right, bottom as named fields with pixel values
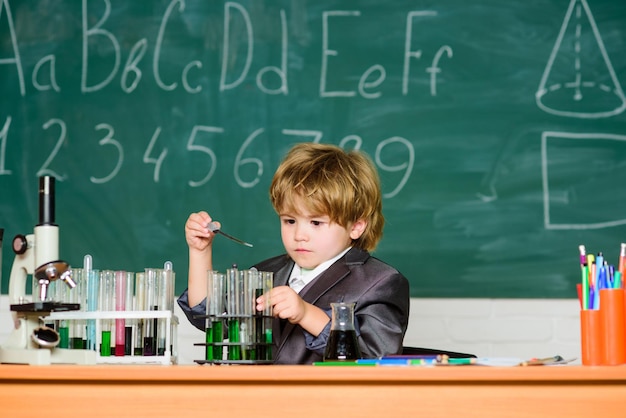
left=280, top=198, right=365, bottom=269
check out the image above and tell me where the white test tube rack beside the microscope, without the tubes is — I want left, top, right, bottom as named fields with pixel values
left=44, top=310, right=178, bottom=365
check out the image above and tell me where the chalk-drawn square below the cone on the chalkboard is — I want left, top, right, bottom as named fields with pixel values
left=541, top=132, right=626, bottom=230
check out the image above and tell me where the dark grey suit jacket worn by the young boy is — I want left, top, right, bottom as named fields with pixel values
left=178, top=248, right=410, bottom=364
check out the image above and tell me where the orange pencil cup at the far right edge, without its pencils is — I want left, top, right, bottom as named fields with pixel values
left=600, top=289, right=626, bottom=366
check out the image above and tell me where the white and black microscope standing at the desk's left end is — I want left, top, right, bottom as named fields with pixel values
left=0, top=176, right=97, bottom=365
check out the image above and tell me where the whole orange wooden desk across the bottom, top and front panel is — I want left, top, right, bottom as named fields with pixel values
left=0, top=365, right=626, bottom=418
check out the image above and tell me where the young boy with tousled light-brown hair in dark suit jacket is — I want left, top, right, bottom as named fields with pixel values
left=178, top=143, right=409, bottom=364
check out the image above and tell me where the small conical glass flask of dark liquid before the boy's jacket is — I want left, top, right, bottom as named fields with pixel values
left=324, top=302, right=361, bottom=361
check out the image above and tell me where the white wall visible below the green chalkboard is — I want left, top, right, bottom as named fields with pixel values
left=0, top=295, right=580, bottom=364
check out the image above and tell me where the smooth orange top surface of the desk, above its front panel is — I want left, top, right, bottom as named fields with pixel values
left=0, top=364, right=626, bottom=384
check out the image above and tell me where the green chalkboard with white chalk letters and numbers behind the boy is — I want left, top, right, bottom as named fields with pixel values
left=0, top=0, right=626, bottom=298
